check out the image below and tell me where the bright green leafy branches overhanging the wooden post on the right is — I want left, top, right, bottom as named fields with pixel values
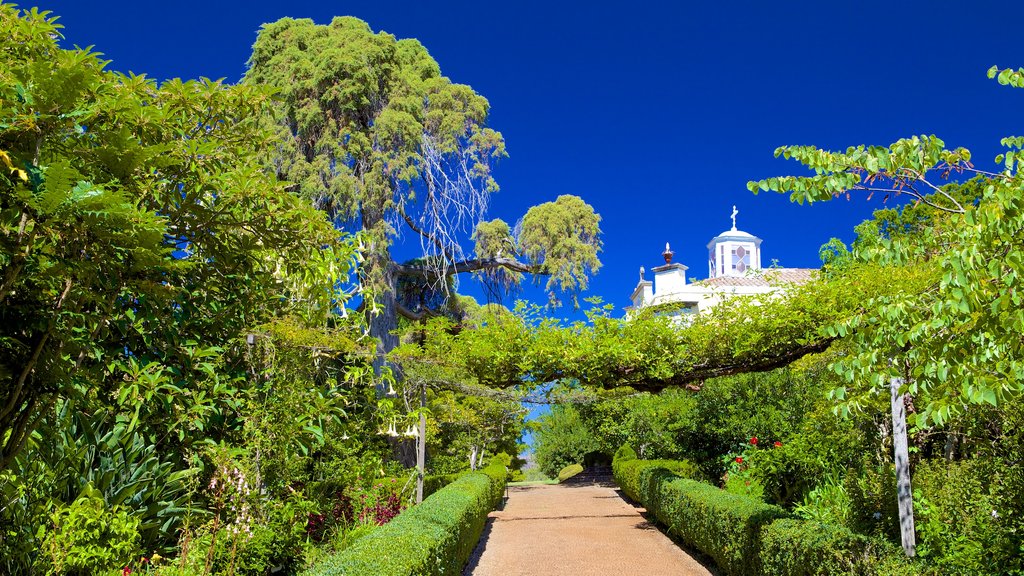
left=748, top=68, right=1024, bottom=425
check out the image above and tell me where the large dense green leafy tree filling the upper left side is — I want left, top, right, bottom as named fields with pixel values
left=0, top=5, right=353, bottom=466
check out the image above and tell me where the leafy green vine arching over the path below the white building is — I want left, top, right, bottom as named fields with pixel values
left=407, top=263, right=921, bottom=392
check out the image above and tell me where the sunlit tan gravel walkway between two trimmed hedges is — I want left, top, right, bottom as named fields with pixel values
left=464, top=484, right=712, bottom=576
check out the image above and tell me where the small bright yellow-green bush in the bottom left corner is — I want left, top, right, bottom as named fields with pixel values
left=39, top=489, right=139, bottom=576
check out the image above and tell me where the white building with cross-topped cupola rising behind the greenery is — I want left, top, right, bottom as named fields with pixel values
left=626, top=206, right=816, bottom=316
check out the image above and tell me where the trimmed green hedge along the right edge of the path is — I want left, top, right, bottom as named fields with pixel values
left=612, top=447, right=913, bottom=576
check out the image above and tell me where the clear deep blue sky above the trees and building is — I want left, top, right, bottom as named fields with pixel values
left=37, top=0, right=1024, bottom=307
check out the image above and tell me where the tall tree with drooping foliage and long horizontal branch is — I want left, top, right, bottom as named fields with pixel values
left=245, top=17, right=600, bottom=366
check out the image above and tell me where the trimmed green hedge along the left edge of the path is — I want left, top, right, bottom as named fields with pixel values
left=303, top=458, right=507, bottom=576
